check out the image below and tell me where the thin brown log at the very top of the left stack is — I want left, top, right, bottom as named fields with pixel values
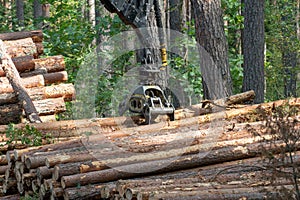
left=0, top=30, right=43, bottom=42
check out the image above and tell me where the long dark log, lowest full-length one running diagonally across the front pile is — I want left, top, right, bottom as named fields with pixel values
left=61, top=138, right=292, bottom=188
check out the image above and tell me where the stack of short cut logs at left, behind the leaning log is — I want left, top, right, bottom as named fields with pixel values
left=0, top=31, right=75, bottom=124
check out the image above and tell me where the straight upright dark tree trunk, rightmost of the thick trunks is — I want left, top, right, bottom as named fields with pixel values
left=242, top=0, right=265, bottom=103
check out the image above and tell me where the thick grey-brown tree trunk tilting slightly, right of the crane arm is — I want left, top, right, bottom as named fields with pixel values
left=191, top=0, right=232, bottom=99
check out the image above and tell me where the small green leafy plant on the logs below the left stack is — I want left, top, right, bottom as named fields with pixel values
left=6, top=124, right=51, bottom=146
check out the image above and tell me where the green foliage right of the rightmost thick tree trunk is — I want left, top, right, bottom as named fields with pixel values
left=265, top=0, right=300, bottom=101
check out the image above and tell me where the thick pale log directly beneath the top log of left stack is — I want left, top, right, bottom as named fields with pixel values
left=4, top=38, right=37, bottom=58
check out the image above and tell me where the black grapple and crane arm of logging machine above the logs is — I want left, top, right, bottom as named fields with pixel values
left=101, top=0, right=175, bottom=124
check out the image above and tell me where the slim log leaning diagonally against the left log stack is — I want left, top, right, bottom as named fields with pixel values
left=0, top=40, right=41, bottom=123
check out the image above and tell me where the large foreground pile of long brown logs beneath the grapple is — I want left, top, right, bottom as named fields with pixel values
left=0, top=96, right=300, bottom=199
